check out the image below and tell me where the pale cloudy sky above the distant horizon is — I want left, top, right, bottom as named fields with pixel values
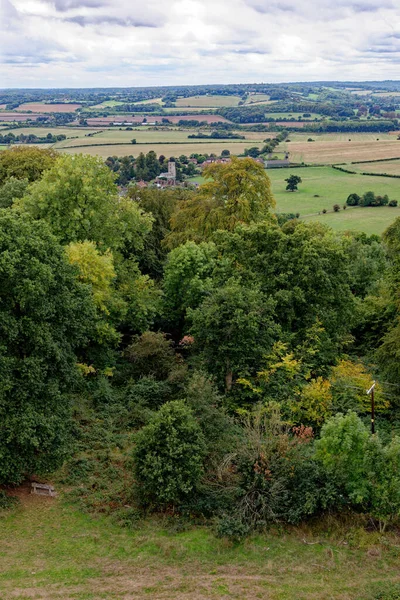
left=0, top=0, right=400, bottom=88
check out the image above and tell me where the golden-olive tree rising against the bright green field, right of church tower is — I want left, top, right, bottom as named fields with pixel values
left=166, top=157, right=275, bottom=248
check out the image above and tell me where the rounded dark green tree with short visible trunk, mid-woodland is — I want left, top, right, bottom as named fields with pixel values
left=188, top=280, right=278, bottom=391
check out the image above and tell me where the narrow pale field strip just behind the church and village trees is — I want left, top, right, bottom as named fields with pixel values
left=57, top=141, right=261, bottom=158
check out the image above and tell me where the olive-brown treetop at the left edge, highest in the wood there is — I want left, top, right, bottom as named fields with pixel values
left=0, top=146, right=57, bottom=184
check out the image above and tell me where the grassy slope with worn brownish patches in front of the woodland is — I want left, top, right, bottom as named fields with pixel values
left=0, top=495, right=400, bottom=600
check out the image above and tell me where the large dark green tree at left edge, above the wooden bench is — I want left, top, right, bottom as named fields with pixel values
left=0, top=211, right=95, bottom=483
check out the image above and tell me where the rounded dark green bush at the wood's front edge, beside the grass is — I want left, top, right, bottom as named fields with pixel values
left=133, top=400, right=205, bottom=506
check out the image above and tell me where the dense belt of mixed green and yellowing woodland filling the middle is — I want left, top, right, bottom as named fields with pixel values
left=0, top=146, right=400, bottom=540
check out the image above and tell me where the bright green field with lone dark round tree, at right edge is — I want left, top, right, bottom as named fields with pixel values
left=267, top=167, right=400, bottom=234
